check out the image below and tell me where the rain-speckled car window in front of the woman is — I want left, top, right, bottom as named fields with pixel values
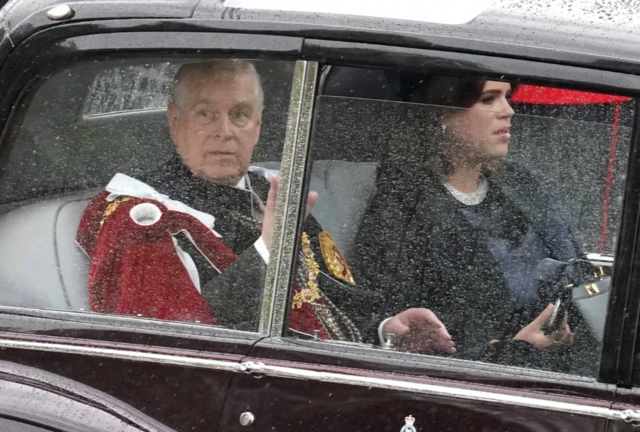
left=289, top=67, right=633, bottom=376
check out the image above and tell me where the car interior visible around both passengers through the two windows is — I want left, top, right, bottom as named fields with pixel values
left=0, top=59, right=631, bottom=330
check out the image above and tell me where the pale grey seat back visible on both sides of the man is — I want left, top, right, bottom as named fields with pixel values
left=0, top=161, right=376, bottom=310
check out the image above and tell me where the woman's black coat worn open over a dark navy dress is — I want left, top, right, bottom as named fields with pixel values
left=354, top=165, right=599, bottom=370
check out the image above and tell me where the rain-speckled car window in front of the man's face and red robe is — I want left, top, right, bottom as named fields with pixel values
left=0, top=58, right=294, bottom=331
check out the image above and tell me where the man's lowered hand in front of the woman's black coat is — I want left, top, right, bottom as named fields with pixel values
left=382, top=308, right=456, bottom=354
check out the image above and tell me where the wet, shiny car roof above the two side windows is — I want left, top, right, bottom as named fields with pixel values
left=0, top=0, right=640, bottom=71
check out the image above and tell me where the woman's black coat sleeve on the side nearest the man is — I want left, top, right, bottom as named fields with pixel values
left=353, top=178, right=474, bottom=343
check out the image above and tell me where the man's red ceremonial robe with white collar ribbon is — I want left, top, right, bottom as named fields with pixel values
left=76, top=191, right=328, bottom=339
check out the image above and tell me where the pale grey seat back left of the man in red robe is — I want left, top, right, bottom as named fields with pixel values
left=0, top=192, right=95, bottom=310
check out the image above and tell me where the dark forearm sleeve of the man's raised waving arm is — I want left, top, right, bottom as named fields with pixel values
left=202, top=246, right=267, bottom=331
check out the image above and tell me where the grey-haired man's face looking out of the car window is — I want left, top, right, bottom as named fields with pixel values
left=167, top=74, right=262, bottom=186
